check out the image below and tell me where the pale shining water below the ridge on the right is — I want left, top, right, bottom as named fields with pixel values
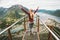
left=37, top=12, right=60, bottom=23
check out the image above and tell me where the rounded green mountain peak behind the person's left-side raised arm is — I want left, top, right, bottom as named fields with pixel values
left=4, top=5, right=28, bottom=23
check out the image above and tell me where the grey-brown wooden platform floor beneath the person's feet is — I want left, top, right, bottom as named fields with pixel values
left=23, top=31, right=39, bottom=40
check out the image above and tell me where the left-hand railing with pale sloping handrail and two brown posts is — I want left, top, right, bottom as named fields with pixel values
left=0, top=15, right=27, bottom=40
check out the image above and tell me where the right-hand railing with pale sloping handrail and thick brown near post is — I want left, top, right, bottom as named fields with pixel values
left=40, top=14, right=60, bottom=40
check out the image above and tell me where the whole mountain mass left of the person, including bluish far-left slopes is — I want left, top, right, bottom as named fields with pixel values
left=0, top=5, right=28, bottom=27
